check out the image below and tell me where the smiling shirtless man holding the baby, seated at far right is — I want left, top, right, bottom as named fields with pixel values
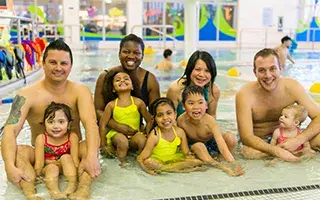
left=236, top=49, right=320, bottom=162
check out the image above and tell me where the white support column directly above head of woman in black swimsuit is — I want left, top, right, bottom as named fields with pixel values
left=127, top=0, right=143, bottom=37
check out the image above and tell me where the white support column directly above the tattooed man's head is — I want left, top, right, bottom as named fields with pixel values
left=62, top=0, right=80, bottom=45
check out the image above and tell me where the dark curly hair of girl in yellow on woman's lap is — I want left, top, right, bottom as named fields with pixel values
left=102, top=69, right=141, bottom=105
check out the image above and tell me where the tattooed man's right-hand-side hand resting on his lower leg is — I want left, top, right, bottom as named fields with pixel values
left=79, top=155, right=101, bottom=178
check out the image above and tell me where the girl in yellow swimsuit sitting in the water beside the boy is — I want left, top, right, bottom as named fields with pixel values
left=137, top=98, right=203, bottom=175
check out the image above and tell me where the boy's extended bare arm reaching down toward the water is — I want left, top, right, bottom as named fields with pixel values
left=207, top=116, right=235, bottom=162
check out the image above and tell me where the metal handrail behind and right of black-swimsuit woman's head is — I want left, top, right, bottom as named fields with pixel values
left=131, top=24, right=178, bottom=49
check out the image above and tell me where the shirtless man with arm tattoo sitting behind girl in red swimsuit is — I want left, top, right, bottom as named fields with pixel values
left=1, top=40, right=101, bottom=199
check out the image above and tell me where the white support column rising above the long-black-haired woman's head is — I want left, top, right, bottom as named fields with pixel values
left=184, top=0, right=199, bottom=60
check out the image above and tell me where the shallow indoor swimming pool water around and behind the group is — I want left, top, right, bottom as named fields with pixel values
left=0, top=48, right=320, bottom=200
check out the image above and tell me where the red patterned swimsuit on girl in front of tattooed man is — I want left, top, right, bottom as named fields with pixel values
left=44, top=133, right=71, bottom=160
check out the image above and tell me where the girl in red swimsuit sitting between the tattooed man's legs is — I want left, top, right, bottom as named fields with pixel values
left=34, top=102, right=79, bottom=199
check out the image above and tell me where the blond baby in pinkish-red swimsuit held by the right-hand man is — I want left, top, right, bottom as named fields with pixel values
left=270, top=105, right=315, bottom=155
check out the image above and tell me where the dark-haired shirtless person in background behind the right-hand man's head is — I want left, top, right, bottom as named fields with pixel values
left=274, top=36, right=294, bottom=69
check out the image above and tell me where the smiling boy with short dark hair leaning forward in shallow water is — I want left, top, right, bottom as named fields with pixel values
left=178, top=86, right=244, bottom=176
